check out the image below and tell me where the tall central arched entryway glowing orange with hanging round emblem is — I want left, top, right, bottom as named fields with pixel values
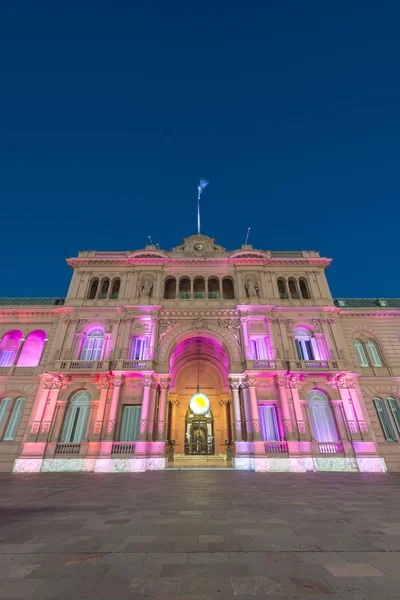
left=167, top=332, right=232, bottom=460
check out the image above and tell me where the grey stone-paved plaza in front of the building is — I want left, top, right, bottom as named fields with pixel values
left=0, top=470, right=400, bottom=600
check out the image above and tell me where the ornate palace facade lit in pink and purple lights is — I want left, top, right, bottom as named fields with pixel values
left=0, top=235, right=400, bottom=472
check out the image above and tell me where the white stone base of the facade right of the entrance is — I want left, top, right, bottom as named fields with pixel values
left=233, top=456, right=387, bottom=473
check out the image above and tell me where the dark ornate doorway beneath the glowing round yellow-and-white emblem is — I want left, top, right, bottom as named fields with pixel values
left=185, top=408, right=215, bottom=456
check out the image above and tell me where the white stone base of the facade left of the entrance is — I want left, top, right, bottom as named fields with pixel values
left=13, top=456, right=165, bottom=473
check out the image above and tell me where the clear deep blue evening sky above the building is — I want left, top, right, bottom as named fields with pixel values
left=0, top=0, right=400, bottom=297
